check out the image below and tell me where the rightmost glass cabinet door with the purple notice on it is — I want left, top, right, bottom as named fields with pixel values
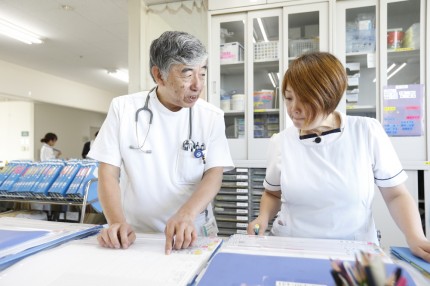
left=380, top=0, right=428, bottom=165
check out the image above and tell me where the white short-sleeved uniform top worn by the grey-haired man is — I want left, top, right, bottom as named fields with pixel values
left=88, top=92, right=233, bottom=235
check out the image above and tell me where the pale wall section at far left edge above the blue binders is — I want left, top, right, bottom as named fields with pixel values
left=0, top=101, right=34, bottom=162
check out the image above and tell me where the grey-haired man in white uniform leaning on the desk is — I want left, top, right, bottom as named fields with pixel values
left=88, top=31, right=233, bottom=254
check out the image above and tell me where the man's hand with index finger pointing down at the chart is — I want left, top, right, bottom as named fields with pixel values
left=164, top=213, right=197, bottom=255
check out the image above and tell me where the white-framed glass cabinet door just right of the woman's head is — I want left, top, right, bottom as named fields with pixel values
left=334, top=0, right=379, bottom=118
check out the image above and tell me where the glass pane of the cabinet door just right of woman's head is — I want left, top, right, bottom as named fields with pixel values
left=345, top=6, right=376, bottom=118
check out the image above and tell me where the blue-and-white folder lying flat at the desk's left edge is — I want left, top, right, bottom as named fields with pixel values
left=0, top=217, right=102, bottom=270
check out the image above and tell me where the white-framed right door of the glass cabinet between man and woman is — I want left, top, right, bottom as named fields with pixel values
left=249, top=9, right=283, bottom=159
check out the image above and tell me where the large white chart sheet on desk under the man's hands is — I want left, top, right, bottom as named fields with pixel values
left=0, top=231, right=222, bottom=286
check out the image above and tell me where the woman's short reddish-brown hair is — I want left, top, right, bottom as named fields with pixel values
left=282, top=52, right=348, bottom=124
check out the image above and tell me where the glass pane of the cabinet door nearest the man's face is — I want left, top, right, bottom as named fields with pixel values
left=220, top=21, right=245, bottom=138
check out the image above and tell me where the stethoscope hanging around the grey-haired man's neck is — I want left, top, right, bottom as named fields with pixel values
left=129, top=86, right=206, bottom=164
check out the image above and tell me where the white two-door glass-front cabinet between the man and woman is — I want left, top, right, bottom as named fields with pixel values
left=209, top=9, right=282, bottom=160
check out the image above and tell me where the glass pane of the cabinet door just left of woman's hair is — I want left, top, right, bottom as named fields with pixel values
left=253, top=16, right=280, bottom=138
